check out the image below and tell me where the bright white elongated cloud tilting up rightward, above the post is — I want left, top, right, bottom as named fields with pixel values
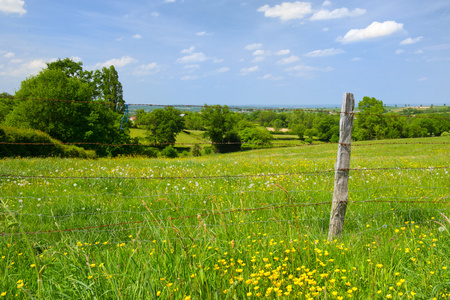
left=337, top=21, right=403, bottom=43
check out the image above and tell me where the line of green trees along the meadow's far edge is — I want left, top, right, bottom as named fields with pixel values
left=0, top=58, right=450, bottom=156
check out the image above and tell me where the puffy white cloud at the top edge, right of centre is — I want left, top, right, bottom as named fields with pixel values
left=258, top=1, right=312, bottom=21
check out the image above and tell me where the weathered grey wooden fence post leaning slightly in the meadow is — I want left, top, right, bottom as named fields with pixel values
left=328, top=93, right=355, bottom=241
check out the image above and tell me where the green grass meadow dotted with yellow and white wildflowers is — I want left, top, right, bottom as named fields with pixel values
left=0, top=135, right=450, bottom=299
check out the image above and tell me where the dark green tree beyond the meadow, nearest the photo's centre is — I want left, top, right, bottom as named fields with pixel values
left=202, top=105, right=241, bottom=153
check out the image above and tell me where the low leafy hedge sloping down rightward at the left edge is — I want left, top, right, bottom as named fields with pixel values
left=0, top=126, right=96, bottom=158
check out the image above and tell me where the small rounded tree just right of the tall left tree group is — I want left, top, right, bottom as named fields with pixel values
left=140, top=106, right=184, bottom=145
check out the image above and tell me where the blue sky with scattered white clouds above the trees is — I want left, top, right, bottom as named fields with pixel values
left=0, top=0, right=450, bottom=107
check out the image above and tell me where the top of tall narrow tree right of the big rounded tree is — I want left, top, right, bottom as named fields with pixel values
left=94, top=65, right=125, bottom=114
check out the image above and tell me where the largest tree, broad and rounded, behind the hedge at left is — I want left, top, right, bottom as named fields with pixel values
left=5, top=59, right=132, bottom=156
